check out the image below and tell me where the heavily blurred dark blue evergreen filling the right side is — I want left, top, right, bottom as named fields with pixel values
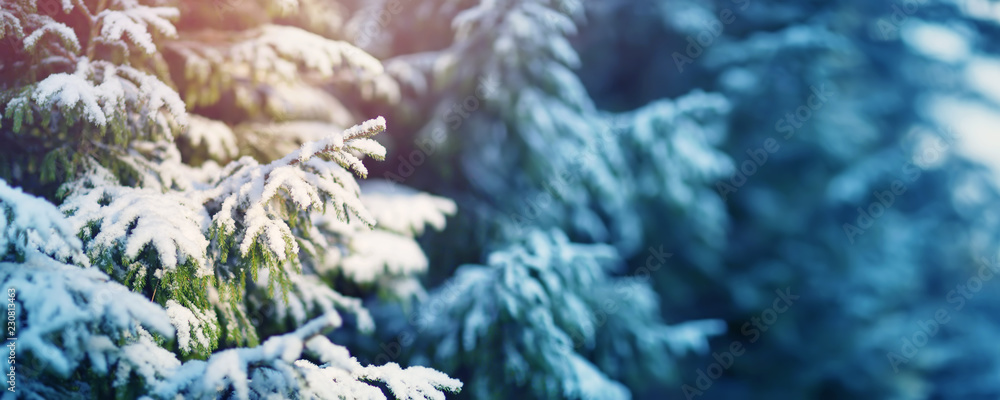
left=580, top=0, right=1000, bottom=398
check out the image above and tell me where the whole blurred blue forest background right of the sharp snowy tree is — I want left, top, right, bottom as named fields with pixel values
left=354, top=0, right=1000, bottom=399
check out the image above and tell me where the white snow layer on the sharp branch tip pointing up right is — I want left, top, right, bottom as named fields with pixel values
left=204, top=117, right=385, bottom=260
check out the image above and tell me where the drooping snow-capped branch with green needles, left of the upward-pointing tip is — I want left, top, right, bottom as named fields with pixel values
left=60, top=162, right=219, bottom=355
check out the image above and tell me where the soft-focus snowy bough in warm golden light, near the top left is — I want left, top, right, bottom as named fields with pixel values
left=172, top=25, right=390, bottom=112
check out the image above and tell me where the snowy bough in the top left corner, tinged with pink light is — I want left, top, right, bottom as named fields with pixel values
left=0, top=0, right=187, bottom=196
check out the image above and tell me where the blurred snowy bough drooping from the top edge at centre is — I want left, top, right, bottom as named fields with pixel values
left=420, top=0, right=660, bottom=253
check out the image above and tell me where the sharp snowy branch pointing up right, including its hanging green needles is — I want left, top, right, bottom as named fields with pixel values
left=198, top=117, right=385, bottom=312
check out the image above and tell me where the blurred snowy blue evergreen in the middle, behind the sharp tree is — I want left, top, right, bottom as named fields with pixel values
left=344, top=0, right=732, bottom=398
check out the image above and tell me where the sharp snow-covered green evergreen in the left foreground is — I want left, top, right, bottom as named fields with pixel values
left=0, top=0, right=462, bottom=399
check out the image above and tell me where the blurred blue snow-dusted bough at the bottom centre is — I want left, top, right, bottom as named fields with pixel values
left=424, top=228, right=628, bottom=399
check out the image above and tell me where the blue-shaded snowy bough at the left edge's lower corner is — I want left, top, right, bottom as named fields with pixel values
left=0, top=181, right=183, bottom=398
